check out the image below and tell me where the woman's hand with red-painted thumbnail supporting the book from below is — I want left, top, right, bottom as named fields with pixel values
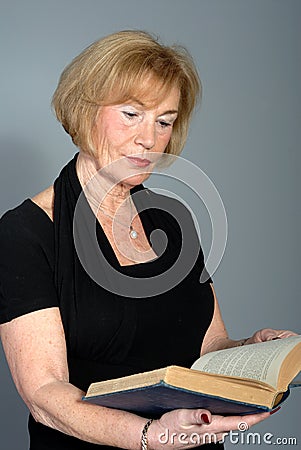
left=148, top=409, right=270, bottom=450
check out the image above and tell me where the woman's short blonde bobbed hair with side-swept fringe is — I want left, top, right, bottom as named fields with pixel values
left=52, top=30, right=201, bottom=155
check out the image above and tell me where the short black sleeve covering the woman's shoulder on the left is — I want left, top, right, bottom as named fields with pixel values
left=0, top=200, right=58, bottom=323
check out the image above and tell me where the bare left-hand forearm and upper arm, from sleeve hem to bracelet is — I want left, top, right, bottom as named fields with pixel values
left=1, top=308, right=146, bottom=449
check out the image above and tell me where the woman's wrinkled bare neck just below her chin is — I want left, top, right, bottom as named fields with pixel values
left=76, top=152, right=130, bottom=214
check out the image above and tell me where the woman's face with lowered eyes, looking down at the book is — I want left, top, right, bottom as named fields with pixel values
left=93, top=88, right=180, bottom=187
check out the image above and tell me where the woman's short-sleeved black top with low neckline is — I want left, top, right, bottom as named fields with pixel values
left=0, top=156, right=220, bottom=450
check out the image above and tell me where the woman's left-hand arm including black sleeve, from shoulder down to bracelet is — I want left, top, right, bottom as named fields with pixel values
left=0, top=207, right=146, bottom=449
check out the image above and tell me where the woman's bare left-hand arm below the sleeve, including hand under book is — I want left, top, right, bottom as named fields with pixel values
left=0, top=307, right=269, bottom=450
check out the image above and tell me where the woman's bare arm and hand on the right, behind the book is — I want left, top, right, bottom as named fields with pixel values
left=201, top=284, right=296, bottom=355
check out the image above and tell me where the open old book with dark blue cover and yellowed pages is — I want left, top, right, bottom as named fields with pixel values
left=83, top=335, right=301, bottom=416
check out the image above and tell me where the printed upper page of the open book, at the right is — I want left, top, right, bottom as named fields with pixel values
left=191, top=336, right=301, bottom=388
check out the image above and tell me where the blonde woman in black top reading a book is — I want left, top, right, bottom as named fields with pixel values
left=0, top=31, right=292, bottom=450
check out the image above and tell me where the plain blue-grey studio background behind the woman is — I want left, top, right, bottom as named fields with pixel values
left=0, top=0, right=301, bottom=450
